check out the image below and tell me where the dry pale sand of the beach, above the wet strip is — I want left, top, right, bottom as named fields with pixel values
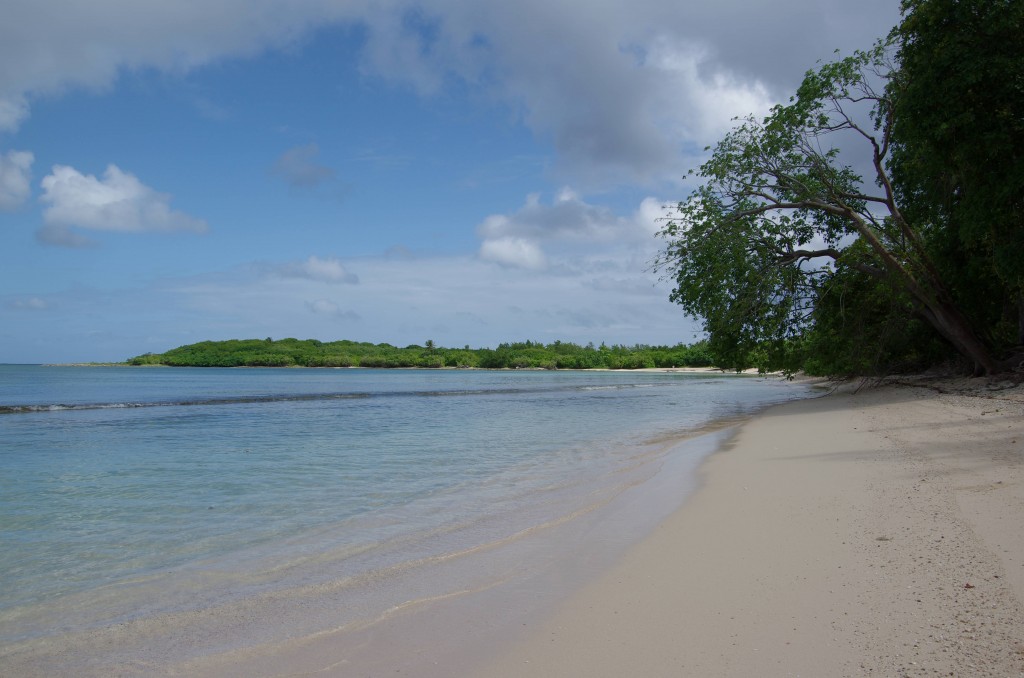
left=474, top=387, right=1024, bottom=678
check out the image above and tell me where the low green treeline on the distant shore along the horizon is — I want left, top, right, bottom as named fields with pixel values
left=128, top=337, right=712, bottom=370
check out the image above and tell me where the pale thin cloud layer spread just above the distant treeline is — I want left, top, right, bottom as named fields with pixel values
left=167, top=244, right=696, bottom=346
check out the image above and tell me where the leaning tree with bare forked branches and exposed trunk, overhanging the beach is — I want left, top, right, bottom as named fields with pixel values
left=655, top=38, right=1001, bottom=374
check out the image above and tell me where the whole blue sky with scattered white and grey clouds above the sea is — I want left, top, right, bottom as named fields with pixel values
left=0, top=0, right=899, bottom=363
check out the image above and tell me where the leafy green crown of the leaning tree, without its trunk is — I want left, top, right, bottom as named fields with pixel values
left=658, top=45, right=891, bottom=369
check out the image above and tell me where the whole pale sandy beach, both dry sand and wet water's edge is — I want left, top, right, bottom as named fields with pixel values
left=8, top=381, right=1024, bottom=678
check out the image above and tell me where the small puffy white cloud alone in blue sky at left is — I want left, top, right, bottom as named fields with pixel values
left=40, top=165, right=208, bottom=237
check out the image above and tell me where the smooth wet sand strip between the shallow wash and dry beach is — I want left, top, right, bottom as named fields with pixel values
left=149, top=422, right=753, bottom=678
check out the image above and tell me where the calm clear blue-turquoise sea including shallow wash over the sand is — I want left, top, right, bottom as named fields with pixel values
left=0, top=365, right=813, bottom=675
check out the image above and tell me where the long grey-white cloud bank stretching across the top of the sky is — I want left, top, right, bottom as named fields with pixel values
left=0, top=0, right=899, bottom=186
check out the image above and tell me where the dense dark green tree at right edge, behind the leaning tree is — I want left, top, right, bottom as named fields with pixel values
left=891, top=0, right=1024, bottom=346
